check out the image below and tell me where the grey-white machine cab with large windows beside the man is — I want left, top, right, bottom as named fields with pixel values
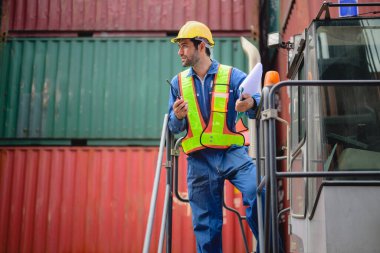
left=264, top=3, right=380, bottom=253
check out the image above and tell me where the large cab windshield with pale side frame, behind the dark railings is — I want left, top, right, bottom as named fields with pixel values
left=306, top=19, right=380, bottom=211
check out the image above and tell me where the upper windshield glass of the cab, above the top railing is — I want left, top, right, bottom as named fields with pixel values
left=316, top=19, right=380, bottom=80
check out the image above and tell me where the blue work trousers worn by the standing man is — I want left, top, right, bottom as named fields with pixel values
left=187, top=146, right=258, bottom=253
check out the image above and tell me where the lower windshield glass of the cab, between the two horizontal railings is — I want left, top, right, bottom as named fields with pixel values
left=319, top=86, right=380, bottom=170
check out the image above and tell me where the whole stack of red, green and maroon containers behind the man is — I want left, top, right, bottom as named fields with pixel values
left=0, top=0, right=254, bottom=252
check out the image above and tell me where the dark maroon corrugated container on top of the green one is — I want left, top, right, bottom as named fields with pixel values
left=3, top=0, right=253, bottom=32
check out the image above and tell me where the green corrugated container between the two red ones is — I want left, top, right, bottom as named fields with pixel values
left=0, top=38, right=246, bottom=145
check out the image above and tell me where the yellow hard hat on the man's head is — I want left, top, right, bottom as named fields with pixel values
left=171, top=21, right=215, bottom=46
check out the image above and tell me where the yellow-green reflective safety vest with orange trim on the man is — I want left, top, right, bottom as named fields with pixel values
left=178, top=64, right=248, bottom=154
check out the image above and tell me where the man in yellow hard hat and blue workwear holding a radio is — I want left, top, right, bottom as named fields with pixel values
left=169, top=21, right=260, bottom=252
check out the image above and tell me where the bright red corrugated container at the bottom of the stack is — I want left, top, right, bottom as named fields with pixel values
left=0, top=147, right=251, bottom=253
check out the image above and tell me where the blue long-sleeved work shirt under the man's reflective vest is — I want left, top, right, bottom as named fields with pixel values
left=168, top=60, right=260, bottom=147
